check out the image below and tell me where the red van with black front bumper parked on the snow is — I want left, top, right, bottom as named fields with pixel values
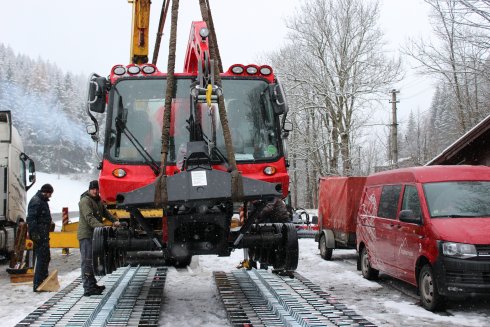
left=356, top=166, right=490, bottom=311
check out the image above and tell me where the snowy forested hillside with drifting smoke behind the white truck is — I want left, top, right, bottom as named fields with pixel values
left=0, top=43, right=97, bottom=174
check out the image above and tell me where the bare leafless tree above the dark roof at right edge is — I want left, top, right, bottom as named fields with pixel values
left=404, top=0, right=488, bottom=135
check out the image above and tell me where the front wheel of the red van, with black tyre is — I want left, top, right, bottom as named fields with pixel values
left=419, top=264, right=445, bottom=311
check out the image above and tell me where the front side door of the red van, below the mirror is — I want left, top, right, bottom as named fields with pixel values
left=394, top=184, right=424, bottom=284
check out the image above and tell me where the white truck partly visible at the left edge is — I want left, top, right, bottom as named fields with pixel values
left=0, top=111, right=36, bottom=268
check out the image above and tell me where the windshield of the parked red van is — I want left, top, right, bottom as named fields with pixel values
left=424, top=181, right=490, bottom=218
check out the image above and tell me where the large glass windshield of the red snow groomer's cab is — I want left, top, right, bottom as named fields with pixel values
left=106, top=78, right=280, bottom=164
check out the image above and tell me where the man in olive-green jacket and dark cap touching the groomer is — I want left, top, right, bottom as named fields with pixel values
left=77, top=180, right=119, bottom=296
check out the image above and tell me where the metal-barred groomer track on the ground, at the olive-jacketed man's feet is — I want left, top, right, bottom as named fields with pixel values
left=16, top=266, right=167, bottom=327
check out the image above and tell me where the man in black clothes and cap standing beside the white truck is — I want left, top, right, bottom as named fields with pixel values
left=27, top=184, right=54, bottom=292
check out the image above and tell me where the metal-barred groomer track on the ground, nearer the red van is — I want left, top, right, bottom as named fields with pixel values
left=214, top=269, right=375, bottom=327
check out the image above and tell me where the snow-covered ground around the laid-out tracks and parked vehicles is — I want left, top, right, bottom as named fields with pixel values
left=0, top=174, right=490, bottom=327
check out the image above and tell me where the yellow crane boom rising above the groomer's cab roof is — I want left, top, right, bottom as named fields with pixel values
left=128, top=0, right=151, bottom=64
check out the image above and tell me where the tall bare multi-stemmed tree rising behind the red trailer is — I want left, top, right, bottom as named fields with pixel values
left=275, top=0, right=400, bottom=179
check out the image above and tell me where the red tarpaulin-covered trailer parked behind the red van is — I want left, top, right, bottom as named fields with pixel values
left=315, top=177, right=366, bottom=260
